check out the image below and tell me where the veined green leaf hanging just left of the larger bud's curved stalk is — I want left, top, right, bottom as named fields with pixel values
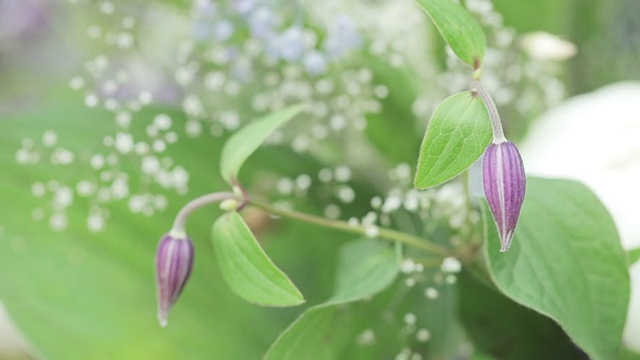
left=414, top=91, right=491, bottom=189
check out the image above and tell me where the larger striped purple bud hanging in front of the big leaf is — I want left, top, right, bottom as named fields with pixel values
left=482, top=141, right=526, bottom=252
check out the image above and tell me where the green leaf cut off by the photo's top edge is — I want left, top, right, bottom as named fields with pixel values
left=416, top=0, right=487, bottom=69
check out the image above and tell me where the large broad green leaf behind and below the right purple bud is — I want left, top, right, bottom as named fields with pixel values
left=484, top=178, right=630, bottom=360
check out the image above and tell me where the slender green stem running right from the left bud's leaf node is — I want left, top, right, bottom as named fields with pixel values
left=249, top=200, right=451, bottom=256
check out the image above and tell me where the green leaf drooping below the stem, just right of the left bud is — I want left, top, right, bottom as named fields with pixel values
left=212, top=211, right=304, bottom=306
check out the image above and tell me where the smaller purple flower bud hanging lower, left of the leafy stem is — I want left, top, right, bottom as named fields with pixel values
left=156, top=233, right=193, bottom=327
